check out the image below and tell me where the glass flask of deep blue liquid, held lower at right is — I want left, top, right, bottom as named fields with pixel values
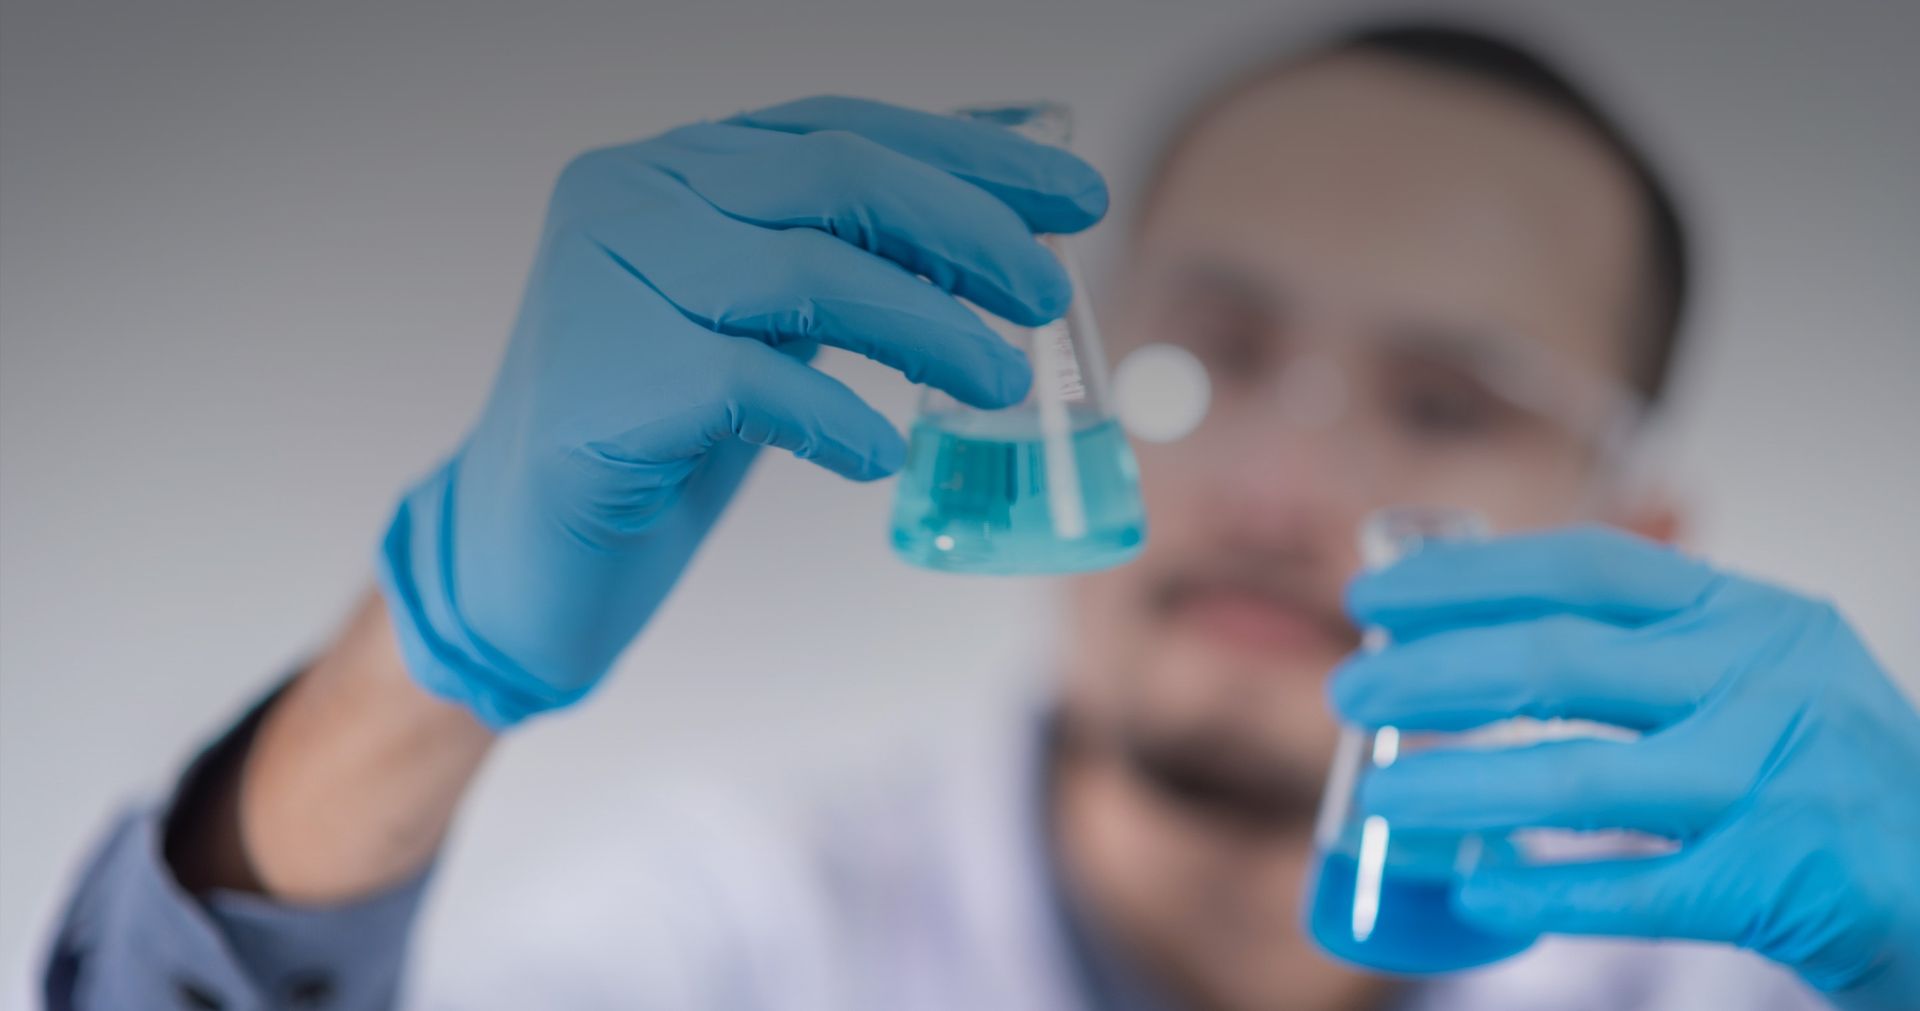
left=1308, top=506, right=1534, bottom=975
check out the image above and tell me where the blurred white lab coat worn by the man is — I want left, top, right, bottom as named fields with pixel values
left=409, top=705, right=1826, bottom=1011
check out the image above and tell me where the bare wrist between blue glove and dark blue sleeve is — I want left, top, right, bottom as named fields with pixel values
left=169, top=593, right=493, bottom=904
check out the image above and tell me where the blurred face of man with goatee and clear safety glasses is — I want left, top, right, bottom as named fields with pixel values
left=1068, top=56, right=1640, bottom=823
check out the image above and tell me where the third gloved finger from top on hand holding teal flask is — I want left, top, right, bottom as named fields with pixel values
left=582, top=194, right=1033, bottom=407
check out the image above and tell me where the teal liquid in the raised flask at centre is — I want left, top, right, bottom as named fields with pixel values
left=893, top=414, right=1146, bottom=576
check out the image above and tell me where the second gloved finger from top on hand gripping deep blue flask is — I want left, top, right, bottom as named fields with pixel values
left=1329, top=612, right=1728, bottom=731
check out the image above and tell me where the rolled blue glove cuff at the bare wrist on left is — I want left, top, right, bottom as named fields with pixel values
left=374, top=457, right=582, bottom=731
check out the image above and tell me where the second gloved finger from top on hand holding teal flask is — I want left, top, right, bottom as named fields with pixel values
left=649, top=123, right=1073, bottom=326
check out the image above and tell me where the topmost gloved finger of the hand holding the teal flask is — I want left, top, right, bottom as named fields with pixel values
left=732, top=96, right=1108, bottom=232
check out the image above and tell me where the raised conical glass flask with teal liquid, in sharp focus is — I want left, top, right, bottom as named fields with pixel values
left=893, top=102, right=1146, bottom=576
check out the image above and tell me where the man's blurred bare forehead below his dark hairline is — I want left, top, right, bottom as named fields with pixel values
left=1137, top=56, right=1640, bottom=370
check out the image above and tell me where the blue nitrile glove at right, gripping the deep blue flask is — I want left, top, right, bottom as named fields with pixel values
left=1331, top=529, right=1920, bottom=1011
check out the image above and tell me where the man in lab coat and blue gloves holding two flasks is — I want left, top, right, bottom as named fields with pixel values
left=44, top=17, right=1920, bottom=1011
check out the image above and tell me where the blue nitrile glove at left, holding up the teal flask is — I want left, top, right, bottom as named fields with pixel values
left=380, top=98, right=1108, bottom=727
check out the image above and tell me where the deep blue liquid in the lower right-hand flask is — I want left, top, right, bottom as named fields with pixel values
left=1308, top=836, right=1534, bottom=975
